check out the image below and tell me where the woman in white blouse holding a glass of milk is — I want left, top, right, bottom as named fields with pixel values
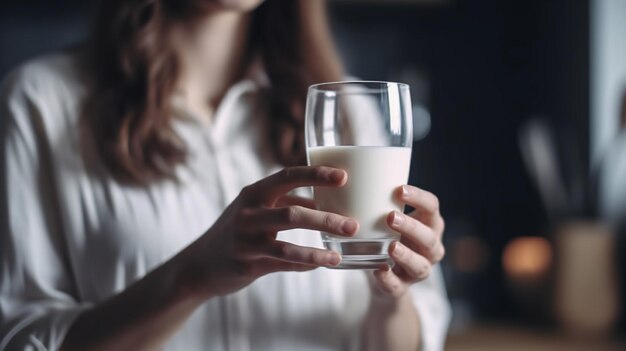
left=0, top=0, right=449, bottom=350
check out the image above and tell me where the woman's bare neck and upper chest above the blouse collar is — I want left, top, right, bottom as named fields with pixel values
left=172, top=11, right=250, bottom=121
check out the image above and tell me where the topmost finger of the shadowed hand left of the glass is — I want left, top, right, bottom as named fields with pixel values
left=242, top=166, right=348, bottom=207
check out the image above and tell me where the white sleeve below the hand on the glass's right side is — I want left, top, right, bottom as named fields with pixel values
left=411, top=265, right=452, bottom=351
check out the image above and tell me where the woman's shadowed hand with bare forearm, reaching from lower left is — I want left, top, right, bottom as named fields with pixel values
left=62, top=167, right=358, bottom=350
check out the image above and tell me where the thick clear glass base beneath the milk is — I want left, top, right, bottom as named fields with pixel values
left=322, top=235, right=397, bottom=269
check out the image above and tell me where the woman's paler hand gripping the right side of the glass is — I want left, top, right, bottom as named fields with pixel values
left=371, top=185, right=445, bottom=299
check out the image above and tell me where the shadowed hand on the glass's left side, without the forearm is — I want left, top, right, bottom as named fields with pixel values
left=178, top=166, right=358, bottom=299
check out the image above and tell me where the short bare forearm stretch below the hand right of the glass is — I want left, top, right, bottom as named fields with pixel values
left=361, top=293, right=421, bottom=351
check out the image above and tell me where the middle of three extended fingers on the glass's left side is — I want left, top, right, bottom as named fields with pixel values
left=240, top=206, right=359, bottom=236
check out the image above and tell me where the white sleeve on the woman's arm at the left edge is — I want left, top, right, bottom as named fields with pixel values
left=0, top=65, right=87, bottom=350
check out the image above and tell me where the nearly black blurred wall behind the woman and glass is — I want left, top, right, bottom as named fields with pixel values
left=0, top=0, right=589, bottom=319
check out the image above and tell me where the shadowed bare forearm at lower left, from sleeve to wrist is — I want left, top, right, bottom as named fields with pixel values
left=61, top=255, right=203, bottom=351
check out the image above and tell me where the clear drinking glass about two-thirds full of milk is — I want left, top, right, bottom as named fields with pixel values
left=305, top=81, right=413, bottom=269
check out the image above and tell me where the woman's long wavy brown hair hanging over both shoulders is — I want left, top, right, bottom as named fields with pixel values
left=83, top=0, right=343, bottom=185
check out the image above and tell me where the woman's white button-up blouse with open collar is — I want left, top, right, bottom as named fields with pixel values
left=0, top=54, right=450, bottom=351
